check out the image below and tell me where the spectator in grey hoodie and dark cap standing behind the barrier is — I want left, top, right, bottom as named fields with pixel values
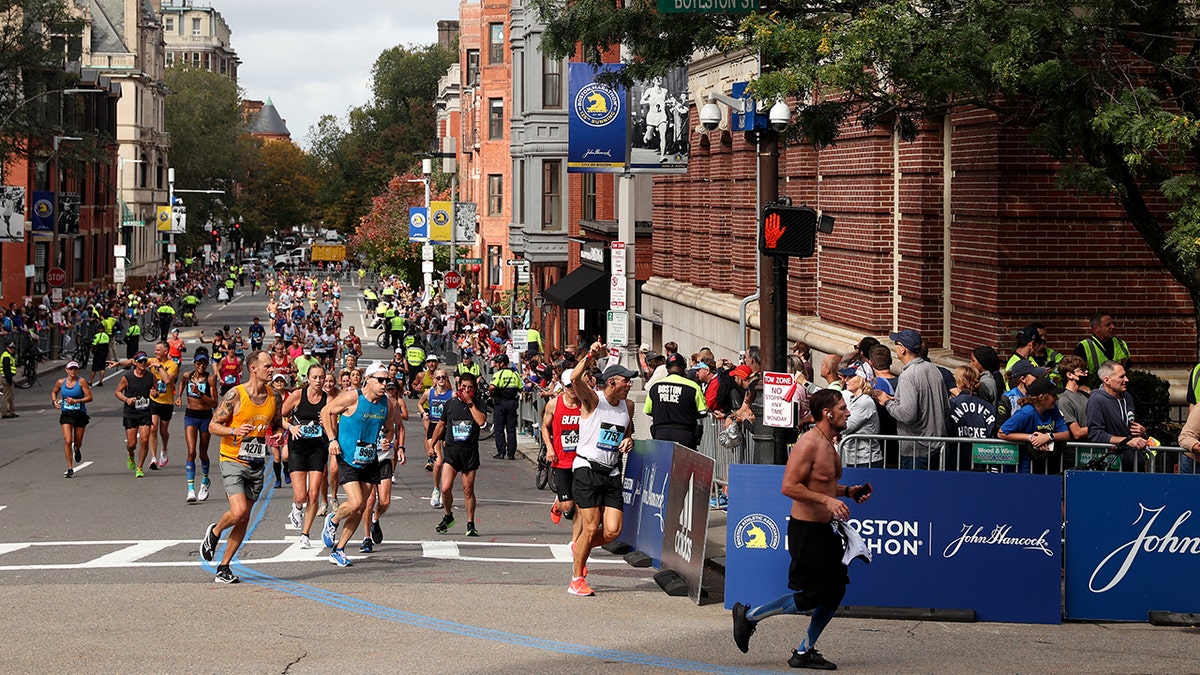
left=875, top=328, right=949, bottom=470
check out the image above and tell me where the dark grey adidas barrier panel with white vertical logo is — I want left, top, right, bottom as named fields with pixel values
left=662, top=443, right=716, bottom=604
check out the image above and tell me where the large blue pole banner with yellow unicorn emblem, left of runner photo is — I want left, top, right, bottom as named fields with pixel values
left=566, top=64, right=629, bottom=173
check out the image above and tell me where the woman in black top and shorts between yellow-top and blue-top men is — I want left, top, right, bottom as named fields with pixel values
left=283, top=365, right=329, bottom=549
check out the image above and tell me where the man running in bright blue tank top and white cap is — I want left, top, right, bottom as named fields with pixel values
left=322, top=364, right=396, bottom=567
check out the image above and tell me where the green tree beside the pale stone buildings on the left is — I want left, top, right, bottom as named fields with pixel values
left=163, top=65, right=245, bottom=247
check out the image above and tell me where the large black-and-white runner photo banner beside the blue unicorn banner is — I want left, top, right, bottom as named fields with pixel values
left=628, top=66, right=691, bottom=173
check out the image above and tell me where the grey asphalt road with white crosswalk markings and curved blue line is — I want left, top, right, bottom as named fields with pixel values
left=0, top=278, right=1200, bottom=674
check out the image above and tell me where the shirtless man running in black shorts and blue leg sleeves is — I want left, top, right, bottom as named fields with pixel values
left=733, top=389, right=870, bottom=670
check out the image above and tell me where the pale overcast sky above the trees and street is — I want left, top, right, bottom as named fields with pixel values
left=213, top=0, right=458, bottom=148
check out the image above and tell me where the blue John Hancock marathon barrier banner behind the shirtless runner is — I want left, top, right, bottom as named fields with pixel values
left=725, top=465, right=1062, bottom=623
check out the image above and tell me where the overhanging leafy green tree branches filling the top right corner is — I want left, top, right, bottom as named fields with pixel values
left=532, top=0, right=1200, bottom=345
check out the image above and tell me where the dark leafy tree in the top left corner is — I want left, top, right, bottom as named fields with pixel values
left=0, top=0, right=84, bottom=167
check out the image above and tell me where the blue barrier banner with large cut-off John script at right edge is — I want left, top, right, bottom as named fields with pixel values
left=1066, top=471, right=1200, bottom=621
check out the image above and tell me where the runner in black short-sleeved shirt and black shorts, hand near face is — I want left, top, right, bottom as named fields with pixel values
left=433, top=372, right=487, bottom=537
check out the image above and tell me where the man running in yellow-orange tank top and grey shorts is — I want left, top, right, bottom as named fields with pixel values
left=200, top=352, right=288, bottom=584
